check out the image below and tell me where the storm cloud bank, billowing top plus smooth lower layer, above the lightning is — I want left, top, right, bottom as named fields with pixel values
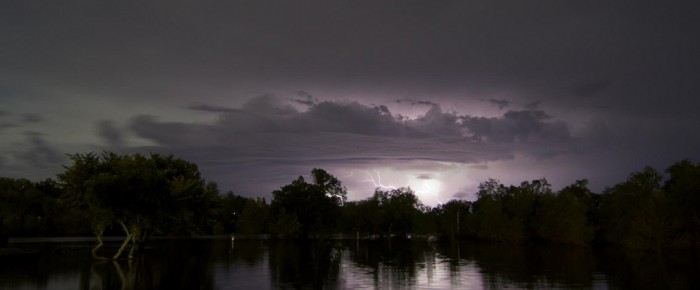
left=130, top=95, right=572, bottom=195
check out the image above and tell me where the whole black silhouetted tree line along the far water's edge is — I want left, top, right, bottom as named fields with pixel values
left=0, top=152, right=700, bottom=251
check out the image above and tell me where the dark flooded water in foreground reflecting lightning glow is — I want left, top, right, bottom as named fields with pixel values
left=0, top=239, right=700, bottom=289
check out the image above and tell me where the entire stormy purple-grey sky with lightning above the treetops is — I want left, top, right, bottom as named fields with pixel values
left=0, top=0, right=700, bottom=205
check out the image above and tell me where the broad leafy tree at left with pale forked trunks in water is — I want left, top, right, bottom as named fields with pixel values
left=58, top=152, right=217, bottom=259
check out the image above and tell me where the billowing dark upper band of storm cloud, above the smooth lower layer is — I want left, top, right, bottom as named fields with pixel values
left=130, top=95, right=571, bottom=159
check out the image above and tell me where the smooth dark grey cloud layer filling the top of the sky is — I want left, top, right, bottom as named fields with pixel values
left=0, top=1, right=700, bottom=114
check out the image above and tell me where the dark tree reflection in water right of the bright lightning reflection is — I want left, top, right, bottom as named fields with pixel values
left=438, top=243, right=700, bottom=289
